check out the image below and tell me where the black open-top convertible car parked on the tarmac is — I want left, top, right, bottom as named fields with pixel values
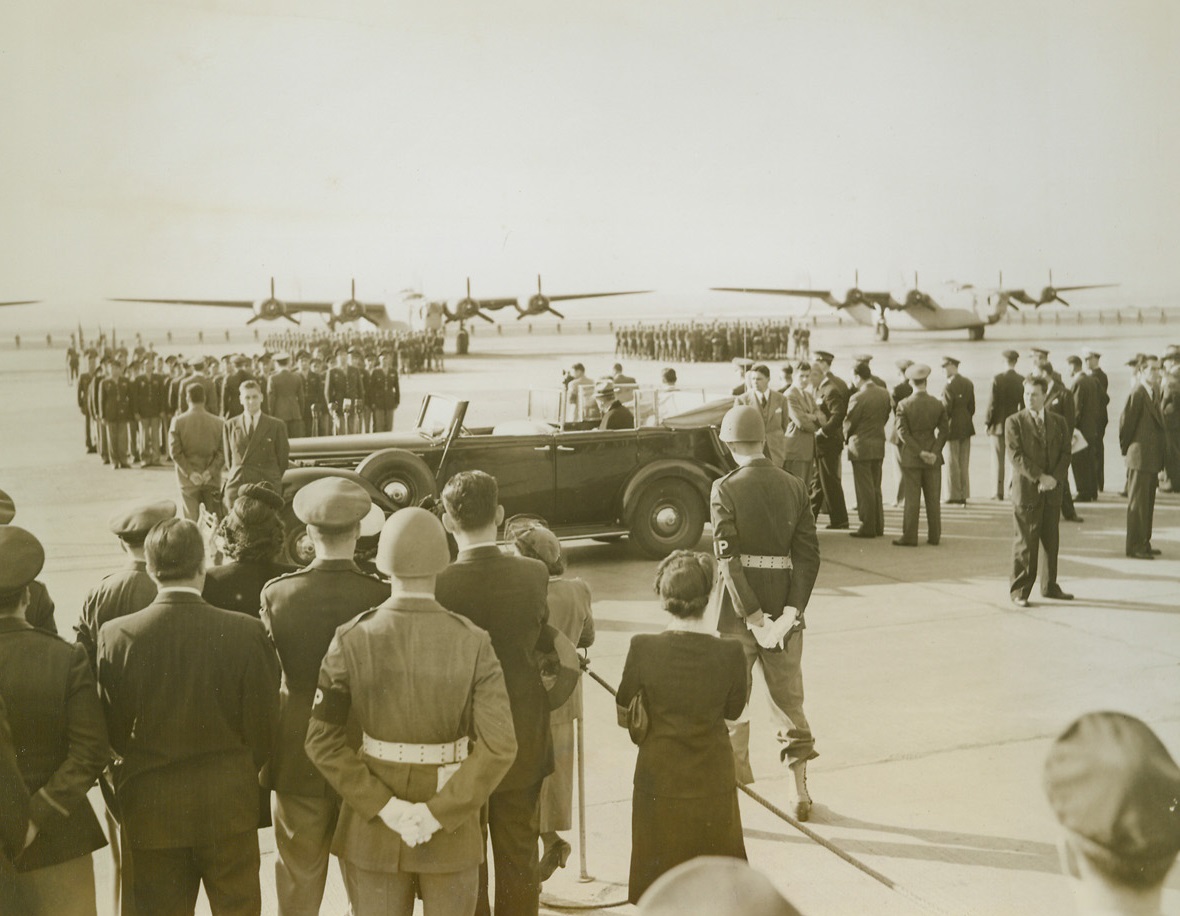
left=284, top=391, right=734, bottom=562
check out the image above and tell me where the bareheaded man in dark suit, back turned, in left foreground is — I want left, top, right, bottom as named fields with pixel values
left=98, top=518, right=278, bottom=914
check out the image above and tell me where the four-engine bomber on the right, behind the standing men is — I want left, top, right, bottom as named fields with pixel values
left=713, top=271, right=1117, bottom=341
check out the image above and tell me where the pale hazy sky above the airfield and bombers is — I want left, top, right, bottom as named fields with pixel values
left=0, top=0, right=1180, bottom=325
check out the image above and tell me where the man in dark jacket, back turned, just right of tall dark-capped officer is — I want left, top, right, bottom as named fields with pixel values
left=844, top=362, right=892, bottom=537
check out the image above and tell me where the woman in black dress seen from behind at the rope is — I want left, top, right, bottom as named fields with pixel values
left=617, top=550, right=749, bottom=903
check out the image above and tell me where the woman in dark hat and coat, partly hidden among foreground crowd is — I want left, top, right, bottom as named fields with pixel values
left=202, top=483, right=295, bottom=617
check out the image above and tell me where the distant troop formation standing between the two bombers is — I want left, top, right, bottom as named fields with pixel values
left=615, top=319, right=811, bottom=362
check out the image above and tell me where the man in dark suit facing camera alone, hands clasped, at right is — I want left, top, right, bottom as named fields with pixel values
left=1004, top=375, right=1074, bottom=608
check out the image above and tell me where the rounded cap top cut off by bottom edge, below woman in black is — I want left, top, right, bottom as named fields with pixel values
left=638, top=856, right=800, bottom=916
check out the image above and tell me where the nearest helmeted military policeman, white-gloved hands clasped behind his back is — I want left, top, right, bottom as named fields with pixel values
left=307, top=508, right=516, bottom=916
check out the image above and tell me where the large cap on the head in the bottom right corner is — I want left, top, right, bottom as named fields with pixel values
left=1044, top=712, right=1180, bottom=861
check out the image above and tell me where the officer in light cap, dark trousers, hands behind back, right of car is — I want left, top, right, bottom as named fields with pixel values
left=893, top=362, right=946, bottom=547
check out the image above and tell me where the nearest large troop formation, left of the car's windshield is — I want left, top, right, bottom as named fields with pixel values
left=77, top=347, right=401, bottom=469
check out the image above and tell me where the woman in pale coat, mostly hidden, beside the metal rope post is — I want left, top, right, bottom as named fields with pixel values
left=504, top=516, right=594, bottom=882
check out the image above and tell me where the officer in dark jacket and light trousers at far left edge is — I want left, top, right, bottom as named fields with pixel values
left=0, top=525, right=110, bottom=916
